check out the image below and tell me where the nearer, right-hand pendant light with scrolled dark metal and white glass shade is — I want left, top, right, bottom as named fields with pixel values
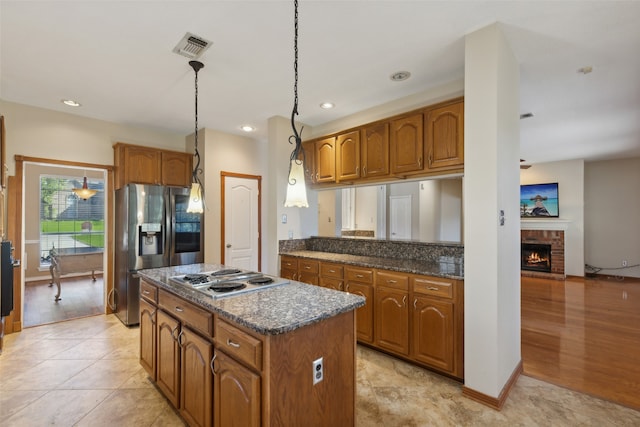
left=284, top=0, right=309, bottom=208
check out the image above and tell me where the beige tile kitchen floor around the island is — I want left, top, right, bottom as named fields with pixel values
left=0, top=315, right=640, bottom=427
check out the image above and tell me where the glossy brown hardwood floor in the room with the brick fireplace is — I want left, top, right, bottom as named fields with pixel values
left=522, top=278, right=640, bottom=410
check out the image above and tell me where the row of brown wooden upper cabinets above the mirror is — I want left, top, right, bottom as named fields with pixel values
left=303, top=98, right=464, bottom=187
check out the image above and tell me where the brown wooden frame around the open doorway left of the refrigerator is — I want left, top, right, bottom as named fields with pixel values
left=5, top=154, right=114, bottom=333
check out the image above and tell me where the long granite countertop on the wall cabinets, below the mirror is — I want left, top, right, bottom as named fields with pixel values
left=280, top=250, right=464, bottom=280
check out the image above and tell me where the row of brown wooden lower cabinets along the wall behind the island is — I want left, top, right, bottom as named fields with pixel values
left=281, top=256, right=464, bottom=379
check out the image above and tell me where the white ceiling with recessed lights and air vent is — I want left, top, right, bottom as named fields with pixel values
left=0, top=0, right=640, bottom=163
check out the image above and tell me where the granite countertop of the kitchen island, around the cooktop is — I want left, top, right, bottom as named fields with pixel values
left=138, top=264, right=365, bottom=335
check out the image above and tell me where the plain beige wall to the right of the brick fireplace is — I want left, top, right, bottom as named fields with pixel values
left=584, top=157, right=640, bottom=277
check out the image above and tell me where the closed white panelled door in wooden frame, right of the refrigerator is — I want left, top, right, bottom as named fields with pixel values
left=224, top=176, right=260, bottom=271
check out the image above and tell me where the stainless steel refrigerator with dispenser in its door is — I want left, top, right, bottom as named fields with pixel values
left=114, top=184, right=204, bottom=326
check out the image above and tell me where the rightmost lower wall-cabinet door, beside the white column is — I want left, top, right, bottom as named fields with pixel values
left=412, top=296, right=455, bottom=373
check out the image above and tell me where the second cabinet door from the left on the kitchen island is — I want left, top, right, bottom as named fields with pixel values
left=156, top=310, right=180, bottom=408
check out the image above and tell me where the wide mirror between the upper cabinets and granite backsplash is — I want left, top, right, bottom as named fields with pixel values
left=318, top=177, right=462, bottom=243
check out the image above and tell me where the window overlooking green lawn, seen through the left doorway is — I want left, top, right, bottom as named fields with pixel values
left=40, top=175, right=104, bottom=265
